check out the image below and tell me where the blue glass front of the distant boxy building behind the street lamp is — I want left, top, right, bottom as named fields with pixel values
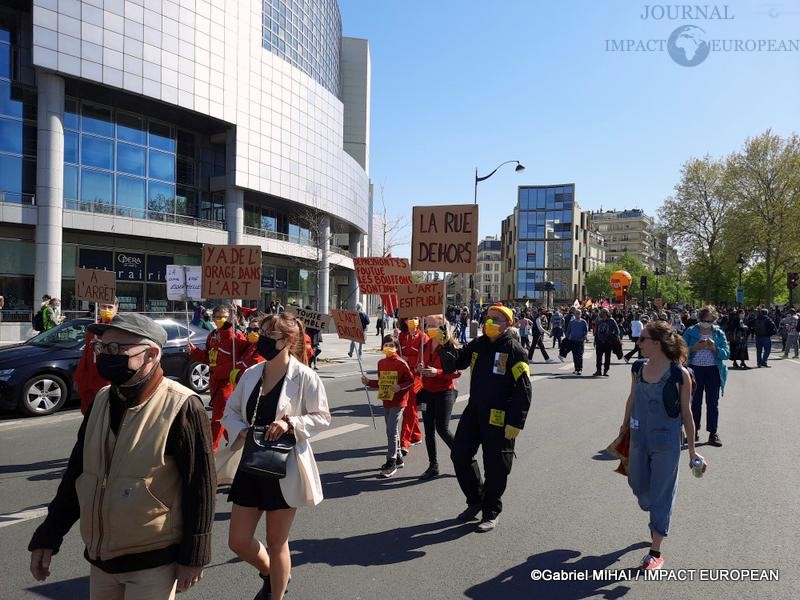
left=516, top=184, right=576, bottom=301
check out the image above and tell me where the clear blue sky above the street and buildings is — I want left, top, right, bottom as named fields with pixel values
left=340, top=0, right=800, bottom=255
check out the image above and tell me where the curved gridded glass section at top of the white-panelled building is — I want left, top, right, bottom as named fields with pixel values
left=263, top=0, right=342, bottom=96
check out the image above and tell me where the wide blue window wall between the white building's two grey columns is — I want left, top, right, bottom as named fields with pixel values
left=64, top=98, right=225, bottom=220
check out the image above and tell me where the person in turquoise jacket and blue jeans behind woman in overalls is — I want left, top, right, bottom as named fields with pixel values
left=683, top=306, right=730, bottom=447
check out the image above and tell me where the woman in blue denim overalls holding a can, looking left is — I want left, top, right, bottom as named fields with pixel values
left=620, top=321, right=705, bottom=569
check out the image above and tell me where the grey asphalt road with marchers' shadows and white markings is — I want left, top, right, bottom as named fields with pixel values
left=0, top=342, right=800, bottom=600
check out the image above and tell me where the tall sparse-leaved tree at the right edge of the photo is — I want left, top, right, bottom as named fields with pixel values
left=726, top=130, right=800, bottom=305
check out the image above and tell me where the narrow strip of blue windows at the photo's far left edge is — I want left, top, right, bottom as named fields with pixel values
left=0, top=15, right=36, bottom=203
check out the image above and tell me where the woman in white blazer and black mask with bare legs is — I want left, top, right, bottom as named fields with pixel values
left=222, top=312, right=331, bottom=600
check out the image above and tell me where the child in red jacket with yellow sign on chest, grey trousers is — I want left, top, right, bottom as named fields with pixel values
left=361, top=335, right=414, bottom=478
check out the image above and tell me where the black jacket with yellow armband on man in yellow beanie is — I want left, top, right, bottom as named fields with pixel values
left=440, top=331, right=532, bottom=429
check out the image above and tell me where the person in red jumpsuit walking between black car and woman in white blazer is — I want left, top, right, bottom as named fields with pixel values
left=188, top=305, right=250, bottom=452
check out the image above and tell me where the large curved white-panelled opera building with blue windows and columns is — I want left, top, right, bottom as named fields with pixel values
left=0, top=0, right=371, bottom=333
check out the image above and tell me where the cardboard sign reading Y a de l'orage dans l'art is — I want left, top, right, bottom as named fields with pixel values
left=202, top=244, right=261, bottom=300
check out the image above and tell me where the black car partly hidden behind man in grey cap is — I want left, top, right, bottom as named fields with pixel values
left=0, top=319, right=210, bottom=416
